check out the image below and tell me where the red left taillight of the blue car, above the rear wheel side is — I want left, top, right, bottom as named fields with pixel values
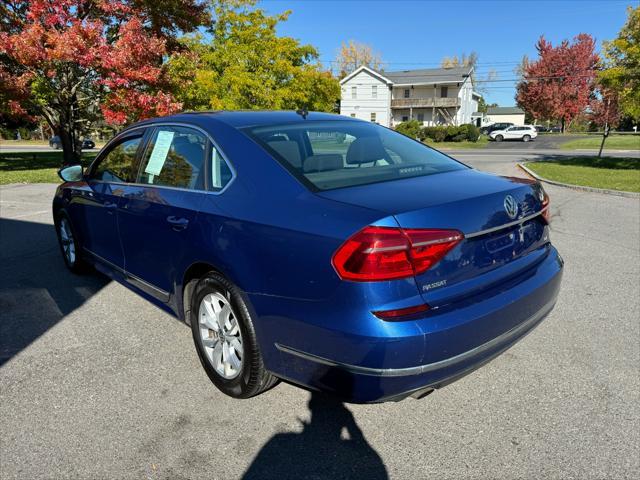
left=332, top=226, right=464, bottom=282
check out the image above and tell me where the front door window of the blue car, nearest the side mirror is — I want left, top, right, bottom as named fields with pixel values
left=91, top=134, right=142, bottom=183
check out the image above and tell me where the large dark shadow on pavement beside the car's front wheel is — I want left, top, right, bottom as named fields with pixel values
left=0, top=218, right=109, bottom=366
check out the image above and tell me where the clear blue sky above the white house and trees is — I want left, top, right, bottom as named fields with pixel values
left=260, top=0, right=638, bottom=106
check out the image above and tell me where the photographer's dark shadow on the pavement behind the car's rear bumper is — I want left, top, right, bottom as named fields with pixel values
left=243, top=392, right=389, bottom=480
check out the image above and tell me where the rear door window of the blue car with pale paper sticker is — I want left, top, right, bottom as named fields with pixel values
left=137, top=126, right=207, bottom=190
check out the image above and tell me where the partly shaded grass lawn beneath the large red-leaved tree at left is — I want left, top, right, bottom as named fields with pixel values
left=0, top=151, right=98, bottom=185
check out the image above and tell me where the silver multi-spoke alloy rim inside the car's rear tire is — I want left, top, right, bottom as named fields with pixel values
left=198, top=293, right=244, bottom=380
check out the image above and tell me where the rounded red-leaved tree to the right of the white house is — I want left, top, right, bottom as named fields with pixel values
left=516, top=33, right=599, bottom=132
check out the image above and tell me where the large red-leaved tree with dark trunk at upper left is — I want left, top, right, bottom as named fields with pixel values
left=0, top=0, right=208, bottom=163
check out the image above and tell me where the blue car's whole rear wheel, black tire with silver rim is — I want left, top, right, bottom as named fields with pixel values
left=190, top=272, right=278, bottom=398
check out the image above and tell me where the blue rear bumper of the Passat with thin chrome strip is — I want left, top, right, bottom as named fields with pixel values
left=252, top=247, right=562, bottom=403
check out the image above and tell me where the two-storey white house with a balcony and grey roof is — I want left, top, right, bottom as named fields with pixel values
left=340, top=66, right=480, bottom=127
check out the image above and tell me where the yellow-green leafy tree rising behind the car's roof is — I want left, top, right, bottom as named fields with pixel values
left=167, top=0, right=340, bottom=111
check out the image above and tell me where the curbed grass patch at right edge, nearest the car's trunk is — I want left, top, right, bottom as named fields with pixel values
left=526, top=157, right=640, bottom=192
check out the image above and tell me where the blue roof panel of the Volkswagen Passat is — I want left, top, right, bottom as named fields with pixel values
left=120, top=110, right=356, bottom=130
